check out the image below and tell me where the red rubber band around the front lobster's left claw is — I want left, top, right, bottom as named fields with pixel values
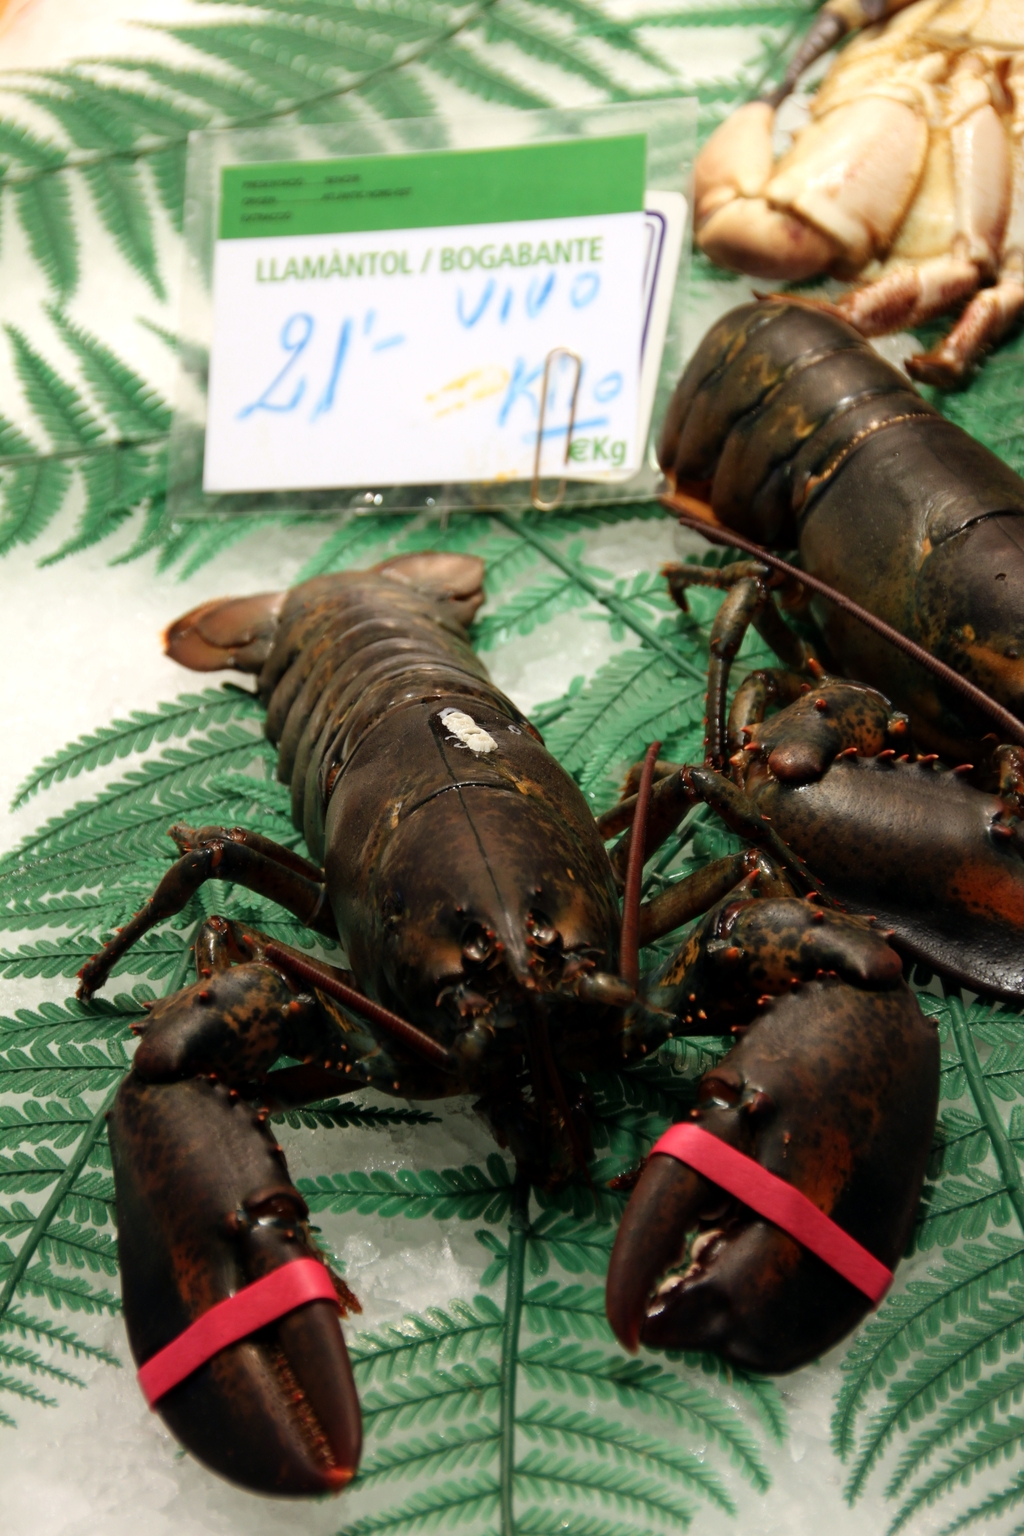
left=138, top=1258, right=339, bottom=1409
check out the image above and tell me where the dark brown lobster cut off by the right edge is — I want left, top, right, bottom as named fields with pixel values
left=662, top=301, right=1024, bottom=1000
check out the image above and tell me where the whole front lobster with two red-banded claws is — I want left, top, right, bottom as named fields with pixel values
left=80, top=554, right=938, bottom=1495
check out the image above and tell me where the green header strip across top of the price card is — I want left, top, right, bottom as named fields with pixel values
left=220, top=134, right=646, bottom=240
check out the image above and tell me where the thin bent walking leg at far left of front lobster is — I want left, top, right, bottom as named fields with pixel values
left=78, top=825, right=338, bottom=998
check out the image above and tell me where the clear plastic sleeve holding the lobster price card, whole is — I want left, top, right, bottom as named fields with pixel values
left=169, top=98, right=695, bottom=518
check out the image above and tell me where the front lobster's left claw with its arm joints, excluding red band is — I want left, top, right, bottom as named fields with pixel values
left=111, top=919, right=368, bottom=1495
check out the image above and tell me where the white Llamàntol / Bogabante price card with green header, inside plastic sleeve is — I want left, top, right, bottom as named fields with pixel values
left=203, top=134, right=685, bottom=492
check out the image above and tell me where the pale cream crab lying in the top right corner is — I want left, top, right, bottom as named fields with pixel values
left=694, top=0, right=1024, bottom=387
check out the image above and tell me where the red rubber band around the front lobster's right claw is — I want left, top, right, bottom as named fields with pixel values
left=651, top=1124, right=892, bottom=1307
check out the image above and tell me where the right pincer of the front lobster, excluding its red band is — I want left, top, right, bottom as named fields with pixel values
left=606, top=970, right=938, bottom=1372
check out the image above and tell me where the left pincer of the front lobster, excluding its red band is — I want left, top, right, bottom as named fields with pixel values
left=111, top=1075, right=361, bottom=1495
